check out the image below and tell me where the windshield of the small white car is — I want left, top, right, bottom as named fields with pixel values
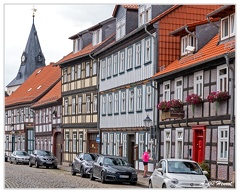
left=168, top=161, right=202, bottom=175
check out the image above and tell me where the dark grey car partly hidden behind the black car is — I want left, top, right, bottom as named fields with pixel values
left=71, top=153, right=98, bottom=177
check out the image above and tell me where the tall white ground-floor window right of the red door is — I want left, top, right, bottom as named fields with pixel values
left=218, top=126, right=229, bottom=161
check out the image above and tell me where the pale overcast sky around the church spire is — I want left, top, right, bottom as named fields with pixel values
left=4, top=4, right=115, bottom=86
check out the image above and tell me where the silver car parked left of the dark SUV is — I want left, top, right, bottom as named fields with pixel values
left=9, top=150, right=30, bottom=164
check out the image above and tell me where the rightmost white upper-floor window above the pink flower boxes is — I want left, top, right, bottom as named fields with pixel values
left=217, top=65, right=228, bottom=92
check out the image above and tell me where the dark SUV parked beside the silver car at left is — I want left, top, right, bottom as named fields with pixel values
left=29, top=150, right=58, bottom=169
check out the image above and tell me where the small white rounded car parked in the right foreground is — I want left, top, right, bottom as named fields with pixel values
left=149, top=159, right=210, bottom=188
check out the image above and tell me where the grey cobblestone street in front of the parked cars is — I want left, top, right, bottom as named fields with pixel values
left=4, top=162, right=146, bottom=189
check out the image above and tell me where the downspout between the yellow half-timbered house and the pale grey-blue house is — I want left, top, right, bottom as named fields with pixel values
left=88, top=54, right=102, bottom=154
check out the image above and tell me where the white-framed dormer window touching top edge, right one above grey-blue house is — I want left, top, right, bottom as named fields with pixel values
left=138, top=4, right=152, bottom=27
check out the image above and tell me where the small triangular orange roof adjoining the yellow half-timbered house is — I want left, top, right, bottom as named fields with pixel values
left=32, top=80, right=62, bottom=108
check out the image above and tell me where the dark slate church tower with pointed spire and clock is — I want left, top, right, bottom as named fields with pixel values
left=7, top=8, right=46, bottom=95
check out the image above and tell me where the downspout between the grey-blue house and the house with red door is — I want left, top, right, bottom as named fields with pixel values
left=144, top=24, right=161, bottom=163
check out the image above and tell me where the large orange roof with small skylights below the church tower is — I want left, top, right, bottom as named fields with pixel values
left=5, top=63, right=61, bottom=107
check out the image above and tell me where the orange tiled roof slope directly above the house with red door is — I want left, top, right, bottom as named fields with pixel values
left=152, top=34, right=235, bottom=79
